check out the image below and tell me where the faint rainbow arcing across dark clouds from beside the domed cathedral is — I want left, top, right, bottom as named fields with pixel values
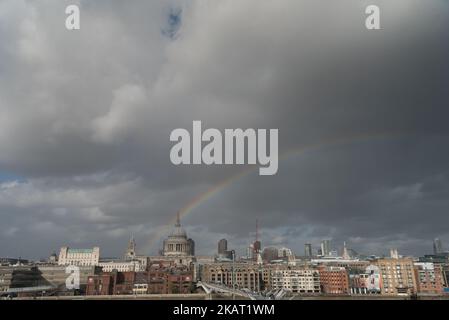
left=144, top=132, right=413, bottom=252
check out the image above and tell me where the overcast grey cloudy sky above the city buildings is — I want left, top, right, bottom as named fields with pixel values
left=0, top=0, right=449, bottom=258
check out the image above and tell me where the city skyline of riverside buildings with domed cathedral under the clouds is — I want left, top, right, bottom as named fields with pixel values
left=0, top=213, right=449, bottom=300
